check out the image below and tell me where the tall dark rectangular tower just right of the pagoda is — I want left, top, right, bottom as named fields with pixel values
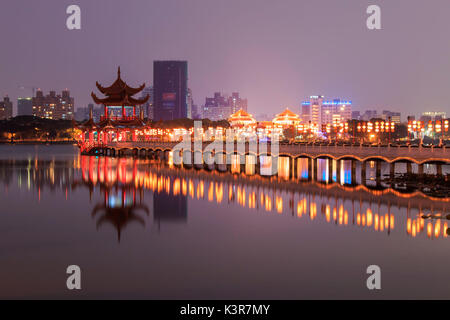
left=153, top=61, right=188, bottom=120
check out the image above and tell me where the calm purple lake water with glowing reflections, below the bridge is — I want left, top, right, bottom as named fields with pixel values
left=0, top=146, right=450, bottom=299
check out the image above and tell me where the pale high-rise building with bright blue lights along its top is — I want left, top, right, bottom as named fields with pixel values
left=302, top=96, right=352, bottom=126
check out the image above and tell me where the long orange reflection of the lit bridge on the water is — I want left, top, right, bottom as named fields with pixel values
left=75, top=156, right=450, bottom=238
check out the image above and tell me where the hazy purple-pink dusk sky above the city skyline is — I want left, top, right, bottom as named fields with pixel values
left=0, top=0, right=450, bottom=116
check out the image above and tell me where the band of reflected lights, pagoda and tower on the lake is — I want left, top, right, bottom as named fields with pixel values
left=0, top=151, right=450, bottom=241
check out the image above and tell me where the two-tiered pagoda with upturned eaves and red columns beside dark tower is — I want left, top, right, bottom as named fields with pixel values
left=91, top=67, right=150, bottom=121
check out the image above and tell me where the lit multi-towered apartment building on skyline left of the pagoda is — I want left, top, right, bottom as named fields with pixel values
left=32, top=89, right=74, bottom=120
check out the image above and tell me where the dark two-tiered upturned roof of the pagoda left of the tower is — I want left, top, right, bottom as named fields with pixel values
left=91, top=67, right=150, bottom=106
